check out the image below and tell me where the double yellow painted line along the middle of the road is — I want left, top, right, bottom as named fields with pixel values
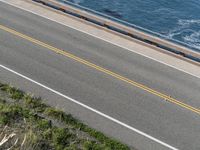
left=0, top=25, right=200, bottom=115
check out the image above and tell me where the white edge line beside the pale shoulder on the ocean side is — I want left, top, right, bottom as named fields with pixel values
left=0, top=0, right=200, bottom=79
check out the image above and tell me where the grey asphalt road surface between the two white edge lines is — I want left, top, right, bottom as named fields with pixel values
left=0, top=2, right=200, bottom=150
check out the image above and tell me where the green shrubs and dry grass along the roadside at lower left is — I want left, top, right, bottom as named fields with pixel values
left=0, top=83, right=132, bottom=150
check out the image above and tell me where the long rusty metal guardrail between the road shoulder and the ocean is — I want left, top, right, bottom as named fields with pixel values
left=32, top=0, right=200, bottom=62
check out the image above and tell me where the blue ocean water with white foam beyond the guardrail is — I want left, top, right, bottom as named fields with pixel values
left=59, top=0, right=200, bottom=52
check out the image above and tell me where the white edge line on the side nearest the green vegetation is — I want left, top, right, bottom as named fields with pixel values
left=0, top=64, right=178, bottom=150
